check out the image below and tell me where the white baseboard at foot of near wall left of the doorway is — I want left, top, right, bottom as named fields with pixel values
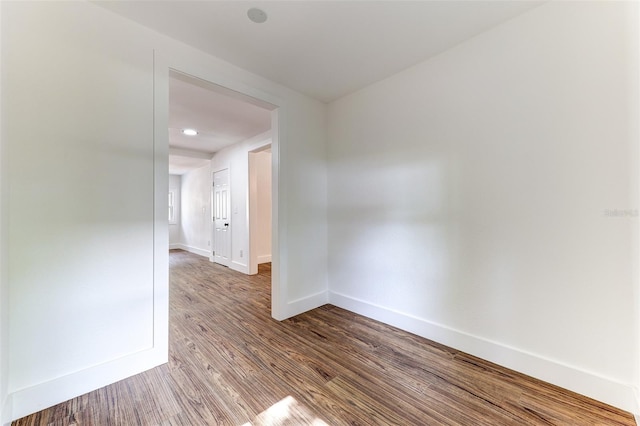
left=10, top=348, right=168, bottom=420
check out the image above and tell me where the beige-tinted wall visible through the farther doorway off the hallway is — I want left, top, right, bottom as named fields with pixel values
left=251, top=150, right=271, bottom=263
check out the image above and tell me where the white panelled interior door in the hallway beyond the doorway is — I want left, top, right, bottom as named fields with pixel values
left=213, top=169, right=231, bottom=266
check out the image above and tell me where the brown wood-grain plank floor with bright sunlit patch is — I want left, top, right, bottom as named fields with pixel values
left=13, top=251, right=635, bottom=426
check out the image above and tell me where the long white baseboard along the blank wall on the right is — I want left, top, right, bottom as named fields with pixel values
left=329, top=292, right=639, bottom=413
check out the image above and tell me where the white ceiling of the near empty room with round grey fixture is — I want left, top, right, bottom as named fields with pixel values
left=96, top=0, right=542, bottom=102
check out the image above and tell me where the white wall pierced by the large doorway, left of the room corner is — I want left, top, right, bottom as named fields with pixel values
left=0, top=2, right=327, bottom=417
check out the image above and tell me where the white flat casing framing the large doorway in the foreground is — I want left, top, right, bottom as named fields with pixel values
left=154, top=51, right=286, bottom=322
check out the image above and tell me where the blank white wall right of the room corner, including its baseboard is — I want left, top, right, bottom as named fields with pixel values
left=328, top=2, right=639, bottom=411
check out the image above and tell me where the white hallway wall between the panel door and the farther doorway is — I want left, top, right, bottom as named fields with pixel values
left=211, top=132, right=271, bottom=274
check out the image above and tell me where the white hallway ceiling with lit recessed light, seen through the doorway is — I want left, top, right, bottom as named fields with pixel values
left=169, top=73, right=271, bottom=174
